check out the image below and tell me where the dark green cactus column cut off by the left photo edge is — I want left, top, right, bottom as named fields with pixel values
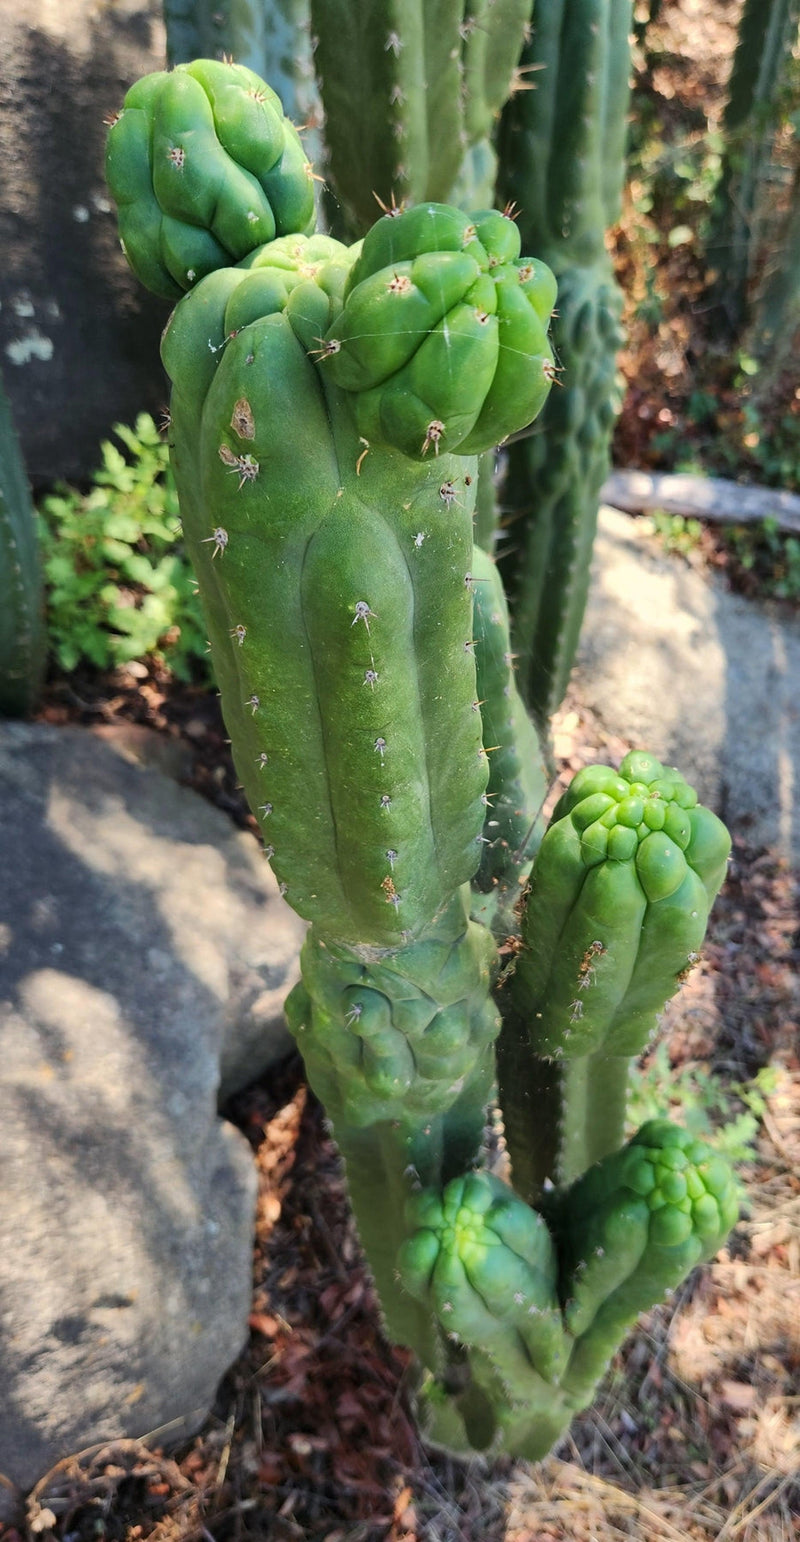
left=0, top=378, right=46, bottom=717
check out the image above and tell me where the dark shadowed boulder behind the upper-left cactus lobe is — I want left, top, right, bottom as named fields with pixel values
left=0, top=0, right=170, bottom=484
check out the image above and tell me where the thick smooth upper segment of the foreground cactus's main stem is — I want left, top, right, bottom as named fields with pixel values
left=163, top=211, right=546, bottom=947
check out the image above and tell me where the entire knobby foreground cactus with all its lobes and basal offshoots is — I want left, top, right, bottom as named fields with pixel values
left=108, top=65, right=735, bottom=1456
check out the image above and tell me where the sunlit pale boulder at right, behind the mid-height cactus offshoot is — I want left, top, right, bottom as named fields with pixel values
left=575, top=509, right=800, bottom=864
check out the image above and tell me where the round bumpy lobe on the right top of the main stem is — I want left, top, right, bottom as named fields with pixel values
left=325, top=204, right=555, bottom=460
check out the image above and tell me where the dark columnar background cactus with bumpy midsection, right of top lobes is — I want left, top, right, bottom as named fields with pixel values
left=498, top=0, right=630, bottom=723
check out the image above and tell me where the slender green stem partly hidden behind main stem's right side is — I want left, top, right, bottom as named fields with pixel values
left=472, top=546, right=549, bottom=912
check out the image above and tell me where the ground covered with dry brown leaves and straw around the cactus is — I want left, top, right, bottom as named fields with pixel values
left=0, top=0, right=800, bottom=1542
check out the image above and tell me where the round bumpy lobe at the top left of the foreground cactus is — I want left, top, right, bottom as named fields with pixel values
left=106, top=59, right=314, bottom=299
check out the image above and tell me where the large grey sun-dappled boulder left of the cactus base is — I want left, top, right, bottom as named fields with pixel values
left=0, top=723, right=302, bottom=1488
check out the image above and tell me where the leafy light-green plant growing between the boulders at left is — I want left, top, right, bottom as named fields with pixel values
left=40, top=413, right=208, bottom=680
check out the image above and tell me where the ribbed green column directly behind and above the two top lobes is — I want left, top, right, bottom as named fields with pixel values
left=311, top=0, right=530, bottom=234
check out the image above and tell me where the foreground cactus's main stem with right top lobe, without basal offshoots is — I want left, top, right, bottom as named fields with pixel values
left=147, top=192, right=552, bottom=1363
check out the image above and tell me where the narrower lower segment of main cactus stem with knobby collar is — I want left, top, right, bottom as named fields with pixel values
left=287, top=893, right=499, bottom=1365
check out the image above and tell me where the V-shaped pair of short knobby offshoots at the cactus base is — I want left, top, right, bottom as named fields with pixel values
left=399, top=1121, right=737, bottom=1460
